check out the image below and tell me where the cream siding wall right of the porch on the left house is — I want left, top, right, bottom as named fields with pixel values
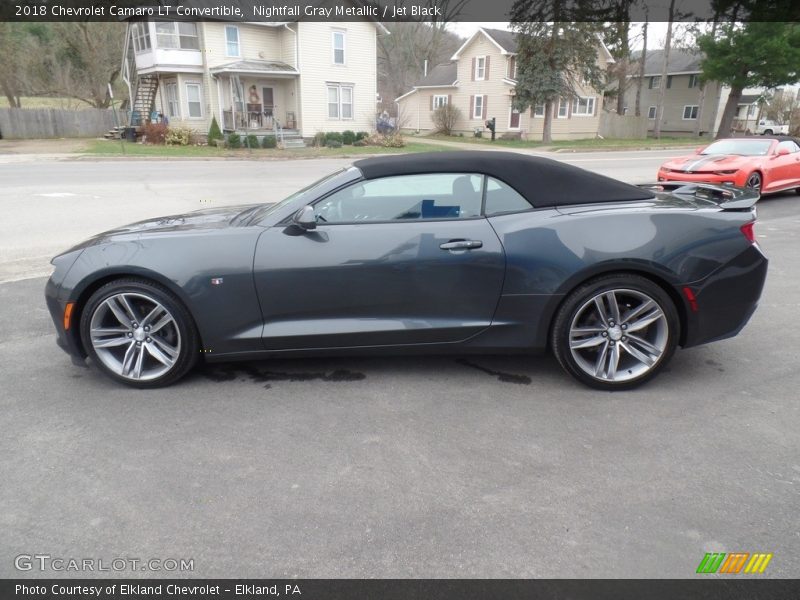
left=295, top=21, right=377, bottom=138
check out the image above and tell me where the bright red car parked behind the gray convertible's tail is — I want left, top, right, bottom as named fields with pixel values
left=658, top=136, right=800, bottom=194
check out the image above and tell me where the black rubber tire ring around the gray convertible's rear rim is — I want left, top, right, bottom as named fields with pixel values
left=550, top=273, right=680, bottom=391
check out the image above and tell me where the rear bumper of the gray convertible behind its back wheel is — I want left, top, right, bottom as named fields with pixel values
left=678, top=244, right=769, bottom=348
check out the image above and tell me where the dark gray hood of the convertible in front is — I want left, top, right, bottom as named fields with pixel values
left=58, top=204, right=264, bottom=254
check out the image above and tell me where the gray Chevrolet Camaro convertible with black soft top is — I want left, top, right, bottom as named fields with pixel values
left=45, top=152, right=767, bottom=390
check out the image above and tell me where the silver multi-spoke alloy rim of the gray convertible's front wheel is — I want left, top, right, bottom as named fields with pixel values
left=89, top=292, right=181, bottom=381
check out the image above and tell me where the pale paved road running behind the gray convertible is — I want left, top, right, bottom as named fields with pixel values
left=0, top=150, right=681, bottom=282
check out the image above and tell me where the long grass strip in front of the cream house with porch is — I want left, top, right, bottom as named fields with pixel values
left=78, top=140, right=448, bottom=159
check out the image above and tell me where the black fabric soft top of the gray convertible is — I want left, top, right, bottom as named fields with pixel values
left=353, top=150, right=654, bottom=208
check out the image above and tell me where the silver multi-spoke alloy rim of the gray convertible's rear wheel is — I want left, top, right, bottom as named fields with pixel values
left=569, top=289, right=669, bottom=382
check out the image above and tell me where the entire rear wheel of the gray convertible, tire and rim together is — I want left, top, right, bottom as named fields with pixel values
left=550, top=273, right=680, bottom=391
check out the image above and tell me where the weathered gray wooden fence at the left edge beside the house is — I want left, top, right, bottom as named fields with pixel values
left=0, top=108, right=125, bottom=139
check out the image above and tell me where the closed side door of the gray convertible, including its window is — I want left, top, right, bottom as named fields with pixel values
left=254, top=173, right=505, bottom=350
